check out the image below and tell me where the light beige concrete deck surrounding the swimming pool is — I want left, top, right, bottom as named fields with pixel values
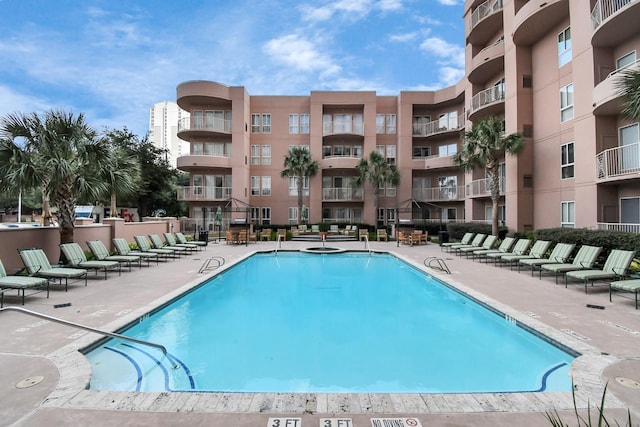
left=0, top=242, right=640, bottom=427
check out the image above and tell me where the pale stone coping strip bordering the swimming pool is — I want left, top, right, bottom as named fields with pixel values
left=43, top=250, right=626, bottom=414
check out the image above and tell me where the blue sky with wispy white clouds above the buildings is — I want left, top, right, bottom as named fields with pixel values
left=0, top=0, right=464, bottom=136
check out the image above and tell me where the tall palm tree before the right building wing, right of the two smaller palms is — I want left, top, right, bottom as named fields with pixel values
left=453, top=117, right=524, bottom=236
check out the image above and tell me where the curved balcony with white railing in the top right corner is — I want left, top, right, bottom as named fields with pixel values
left=591, top=0, right=640, bottom=47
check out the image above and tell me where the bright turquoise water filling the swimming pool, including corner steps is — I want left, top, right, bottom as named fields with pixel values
left=87, top=252, right=573, bottom=393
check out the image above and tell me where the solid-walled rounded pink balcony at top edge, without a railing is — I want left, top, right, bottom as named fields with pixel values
left=513, top=0, right=569, bottom=46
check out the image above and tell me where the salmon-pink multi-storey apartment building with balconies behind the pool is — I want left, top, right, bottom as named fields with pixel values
left=177, top=0, right=640, bottom=232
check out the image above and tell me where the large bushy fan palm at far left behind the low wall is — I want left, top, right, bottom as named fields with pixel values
left=0, top=110, right=111, bottom=243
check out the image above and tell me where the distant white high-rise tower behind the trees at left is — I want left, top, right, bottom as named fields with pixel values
left=149, top=101, right=189, bottom=168
